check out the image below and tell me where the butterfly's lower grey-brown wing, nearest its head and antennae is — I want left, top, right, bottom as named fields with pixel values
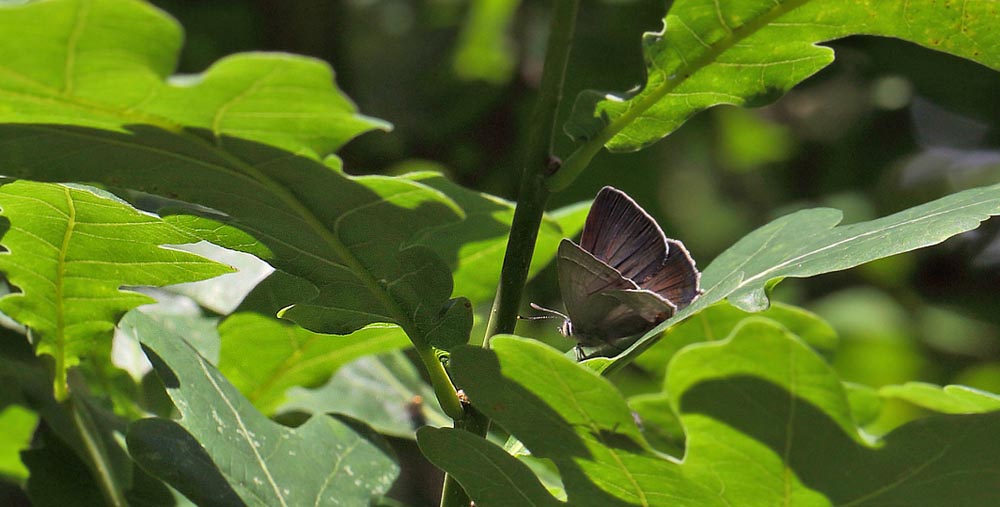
left=558, top=239, right=675, bottom=347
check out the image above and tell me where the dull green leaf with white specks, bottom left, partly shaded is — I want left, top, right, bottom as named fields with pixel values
left=122, top=312, right=399, bottom=507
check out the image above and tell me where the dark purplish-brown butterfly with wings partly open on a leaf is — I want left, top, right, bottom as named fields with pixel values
left=531, top=187, right=701, bottom=359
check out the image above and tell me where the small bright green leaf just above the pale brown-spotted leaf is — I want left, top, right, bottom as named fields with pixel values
left=219, top=312, right=410, bottom=415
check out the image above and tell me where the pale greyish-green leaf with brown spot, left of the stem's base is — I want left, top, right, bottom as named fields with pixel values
left=279, top=352, right=451, bottom=438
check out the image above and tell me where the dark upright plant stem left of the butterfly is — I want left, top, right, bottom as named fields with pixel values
left=441, top=0, right=580, bottom=507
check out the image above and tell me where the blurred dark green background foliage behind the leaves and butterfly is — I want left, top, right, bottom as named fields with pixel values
left=143, top=0, right=1000, bottom=504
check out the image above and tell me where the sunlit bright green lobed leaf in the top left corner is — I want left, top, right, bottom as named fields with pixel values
left=0, top=0, right=387, bottom=158
